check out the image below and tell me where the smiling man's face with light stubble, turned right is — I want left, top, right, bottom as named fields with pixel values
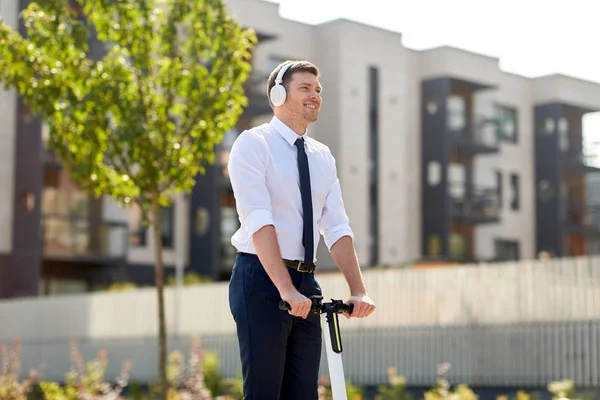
left=282, top=72, right=322, bottom=123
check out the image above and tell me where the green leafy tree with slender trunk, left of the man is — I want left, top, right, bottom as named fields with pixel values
left=0, top=0, right=256, bottom=398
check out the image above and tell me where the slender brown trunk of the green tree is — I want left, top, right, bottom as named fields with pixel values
left=150, top=193, right=168, bottom=400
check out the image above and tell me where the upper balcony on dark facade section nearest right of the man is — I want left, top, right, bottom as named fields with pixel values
left=447, top=113, right=500, bottom=156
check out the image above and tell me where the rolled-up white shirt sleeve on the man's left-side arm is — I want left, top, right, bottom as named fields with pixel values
left=227, top=131, right=273, bottom=236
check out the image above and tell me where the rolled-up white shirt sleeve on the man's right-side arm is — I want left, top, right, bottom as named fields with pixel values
left=318, top=155, right=354, bottom=251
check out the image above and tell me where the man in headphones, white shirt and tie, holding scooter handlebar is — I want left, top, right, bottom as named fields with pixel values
left=228, top=61, right=375, bottom=400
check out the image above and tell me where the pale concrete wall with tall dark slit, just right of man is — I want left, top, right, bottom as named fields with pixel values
left=320, top=20, right=409, bottom=264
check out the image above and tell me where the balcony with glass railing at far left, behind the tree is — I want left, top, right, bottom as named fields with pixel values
left=42, top=214, right=129, bottom=264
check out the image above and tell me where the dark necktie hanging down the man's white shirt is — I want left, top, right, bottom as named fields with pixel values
left=296, top=138, right=315, bottom=265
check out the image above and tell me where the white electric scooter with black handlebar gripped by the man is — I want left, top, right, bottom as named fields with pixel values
left=279, top=296, right=354, bottom=400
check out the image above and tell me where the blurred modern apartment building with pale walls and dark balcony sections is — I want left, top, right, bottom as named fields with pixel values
left=0, top=0, right=600, bottom=297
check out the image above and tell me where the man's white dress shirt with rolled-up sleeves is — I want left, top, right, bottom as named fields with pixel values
left=227, top=117, right=354, bottom=260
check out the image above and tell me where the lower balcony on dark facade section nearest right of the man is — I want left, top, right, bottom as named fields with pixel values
left=449, top=182, right=500, bottom=224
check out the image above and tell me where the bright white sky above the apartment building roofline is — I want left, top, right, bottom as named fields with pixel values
left=268, top=0, right=600, bottom=148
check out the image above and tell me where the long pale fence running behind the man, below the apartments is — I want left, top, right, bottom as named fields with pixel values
left=0, top=257, right=600, bottom=386
